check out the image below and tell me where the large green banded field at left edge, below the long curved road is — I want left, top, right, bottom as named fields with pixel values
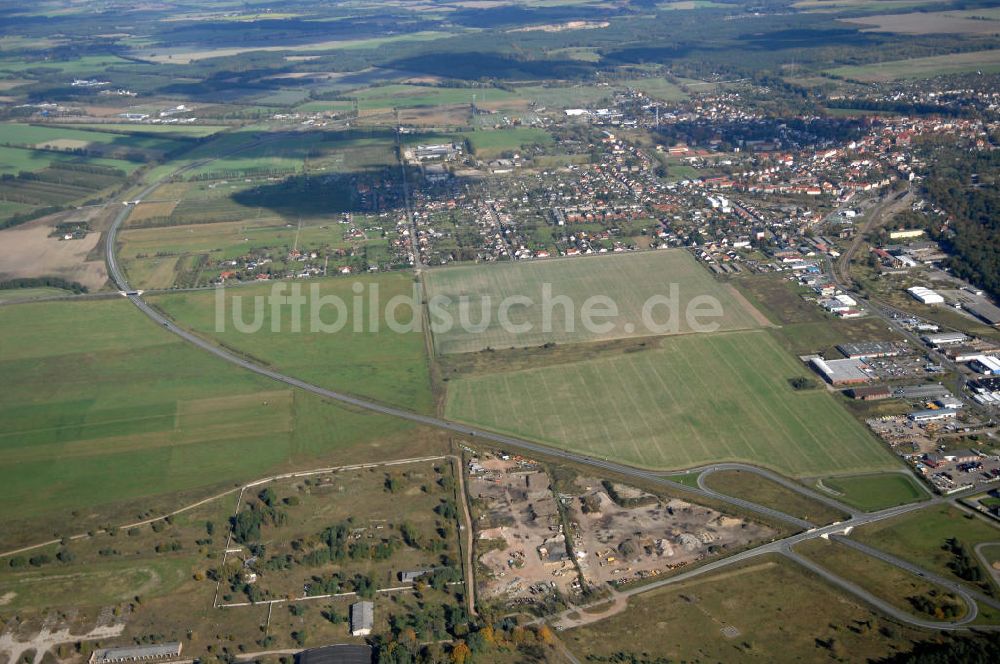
left=0, top=300, right=412, bottom=536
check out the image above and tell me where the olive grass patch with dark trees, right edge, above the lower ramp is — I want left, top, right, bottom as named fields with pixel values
left=852, top=504, right=1000, bottom=596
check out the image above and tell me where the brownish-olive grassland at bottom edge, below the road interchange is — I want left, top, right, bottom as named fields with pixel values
left=561, top=558, right=921, bottom=662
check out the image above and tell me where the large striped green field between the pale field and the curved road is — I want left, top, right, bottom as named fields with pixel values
left=445, top=330, right=897, bottom=477
